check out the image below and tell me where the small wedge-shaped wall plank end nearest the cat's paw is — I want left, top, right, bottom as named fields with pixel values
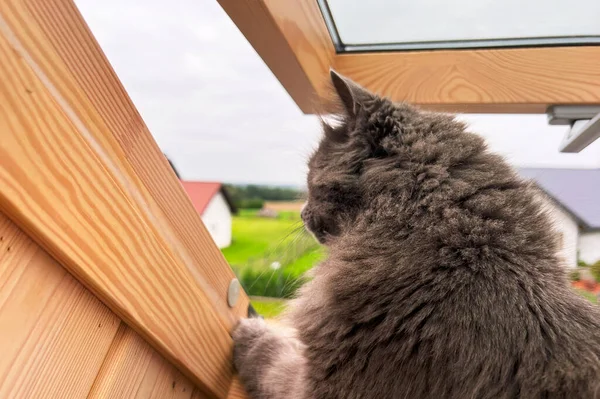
left=88, top=324, right=194, bottom=399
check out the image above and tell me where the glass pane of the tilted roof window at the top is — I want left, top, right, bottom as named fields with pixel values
left=324, top=0, right=600, bottom=50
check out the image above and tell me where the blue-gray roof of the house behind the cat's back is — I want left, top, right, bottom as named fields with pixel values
left=519, top=168, right=600, bottom=230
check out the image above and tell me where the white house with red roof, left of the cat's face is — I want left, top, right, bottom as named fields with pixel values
left=181, top=181, right=235, bottom=248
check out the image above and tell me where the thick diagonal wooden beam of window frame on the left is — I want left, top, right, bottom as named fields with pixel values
left=0, top=0, right=249, bottom=397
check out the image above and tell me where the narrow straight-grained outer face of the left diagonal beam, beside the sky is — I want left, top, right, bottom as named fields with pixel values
left=14, top=0, right=249, bottom=322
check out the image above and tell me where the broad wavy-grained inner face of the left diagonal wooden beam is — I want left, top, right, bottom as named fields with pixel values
left=0, top=2, right=235, bottom=397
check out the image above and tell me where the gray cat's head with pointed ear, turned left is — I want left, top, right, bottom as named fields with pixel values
left=302, top=70, right=483, bottom=244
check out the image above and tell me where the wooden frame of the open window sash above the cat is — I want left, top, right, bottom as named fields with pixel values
left=218, top=0, right=600, bottom=114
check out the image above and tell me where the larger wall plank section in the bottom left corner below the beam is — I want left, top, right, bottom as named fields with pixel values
left=0, top=214, right=120, bottom=398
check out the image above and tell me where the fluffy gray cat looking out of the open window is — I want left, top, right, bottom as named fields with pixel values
left=232, top=71, right=600, bottom=399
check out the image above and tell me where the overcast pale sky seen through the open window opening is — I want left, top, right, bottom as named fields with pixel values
left=76, top=0, right=600, bottom=185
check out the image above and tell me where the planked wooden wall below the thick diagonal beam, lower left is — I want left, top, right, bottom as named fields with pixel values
left=0, top=213, right=207, bottom=399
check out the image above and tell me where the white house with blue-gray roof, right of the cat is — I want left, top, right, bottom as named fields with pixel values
left=519, top=168, right=600, bottom=267
